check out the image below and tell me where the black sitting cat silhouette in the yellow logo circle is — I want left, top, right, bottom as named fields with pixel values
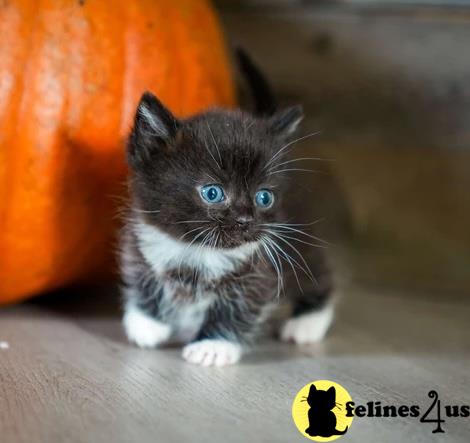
left=304, top=384, right=348, bottom=437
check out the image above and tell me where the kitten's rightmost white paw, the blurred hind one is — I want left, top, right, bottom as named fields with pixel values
left=281, top=305, right=334, bottom=345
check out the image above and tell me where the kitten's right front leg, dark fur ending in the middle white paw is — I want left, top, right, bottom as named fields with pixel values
left=183, top=301, right=259, bottom=366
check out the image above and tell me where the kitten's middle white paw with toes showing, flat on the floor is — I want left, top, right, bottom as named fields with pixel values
left=183, top=340, right=242, bottom=366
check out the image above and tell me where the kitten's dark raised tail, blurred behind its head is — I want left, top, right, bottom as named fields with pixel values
left=235, top=48, right=277, bottom=116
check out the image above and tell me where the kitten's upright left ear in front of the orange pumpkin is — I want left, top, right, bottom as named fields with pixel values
left=128, top=92, right=179, bottom=165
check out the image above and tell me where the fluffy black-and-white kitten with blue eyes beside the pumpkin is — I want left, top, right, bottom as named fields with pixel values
left=121, top=55, right=333, bottom=366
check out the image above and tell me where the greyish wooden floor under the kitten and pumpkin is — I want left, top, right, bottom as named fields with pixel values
left=0, top=288, right=470, bottom=443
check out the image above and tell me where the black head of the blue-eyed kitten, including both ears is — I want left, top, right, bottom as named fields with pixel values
left=128, top=93, right=302, bottom=248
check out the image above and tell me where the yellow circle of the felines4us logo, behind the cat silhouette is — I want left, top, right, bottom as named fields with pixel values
left=292, top=380, right=353, bottom=441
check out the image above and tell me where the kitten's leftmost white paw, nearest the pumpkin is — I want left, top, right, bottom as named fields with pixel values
left=122, top=306, right=171, bottom=348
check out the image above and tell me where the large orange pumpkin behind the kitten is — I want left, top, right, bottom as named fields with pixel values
left=0, top=0, right=234, bottom=303
